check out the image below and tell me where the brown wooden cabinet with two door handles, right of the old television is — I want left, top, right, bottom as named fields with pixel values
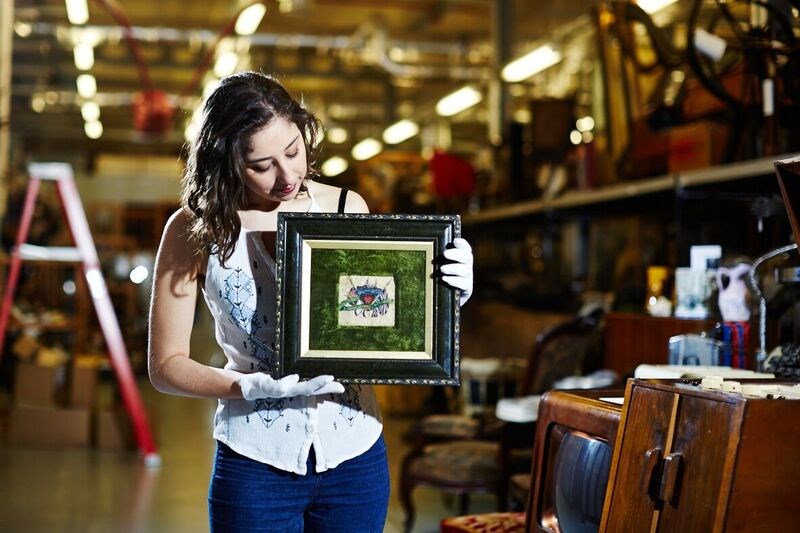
left=600, top=379, right=800, bottom=533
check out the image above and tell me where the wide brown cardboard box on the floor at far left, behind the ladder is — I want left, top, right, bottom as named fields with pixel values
left=8, top=405, right=91, bottom=448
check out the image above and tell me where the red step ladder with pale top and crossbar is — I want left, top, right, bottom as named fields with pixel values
left=0, top=163, right=161, bottom=468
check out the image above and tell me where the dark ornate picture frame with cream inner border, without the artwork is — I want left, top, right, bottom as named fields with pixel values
left=275, top=213, right=461, bottom=385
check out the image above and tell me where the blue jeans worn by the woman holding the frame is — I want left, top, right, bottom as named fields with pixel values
left=208, top=435, right=389, bottom=533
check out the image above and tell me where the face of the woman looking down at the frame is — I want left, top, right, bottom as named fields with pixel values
left=245, top=117, right=308, bottom=208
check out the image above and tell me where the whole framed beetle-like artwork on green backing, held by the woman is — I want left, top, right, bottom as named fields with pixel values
left=275, top=213, right=461, bottom=385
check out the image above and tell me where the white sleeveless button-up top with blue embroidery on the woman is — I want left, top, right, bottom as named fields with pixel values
left=203, top=188, right=383, bottom=475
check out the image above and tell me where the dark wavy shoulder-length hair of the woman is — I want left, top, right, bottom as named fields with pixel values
left=181, top=72, right=319, bottom=264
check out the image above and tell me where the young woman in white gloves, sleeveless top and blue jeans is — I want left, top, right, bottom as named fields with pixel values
left=148, top=72, right=472, bottom=532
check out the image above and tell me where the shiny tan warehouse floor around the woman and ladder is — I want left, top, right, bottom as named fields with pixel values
left=0, top=308, right=494, bottom=533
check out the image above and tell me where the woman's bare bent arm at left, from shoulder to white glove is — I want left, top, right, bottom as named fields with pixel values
left=147, top=210, right=242, bottom=399
